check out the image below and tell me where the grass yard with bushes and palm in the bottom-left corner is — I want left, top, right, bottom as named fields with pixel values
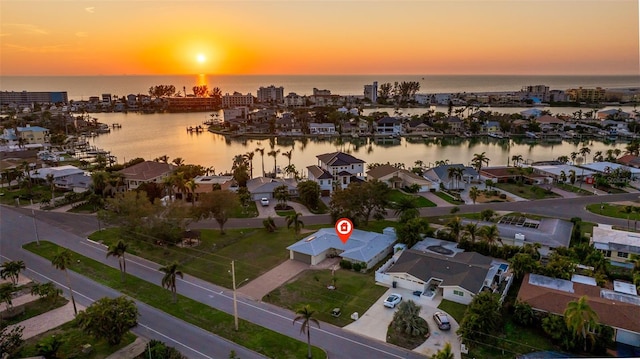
left=15, top=321, right=136, bottom=359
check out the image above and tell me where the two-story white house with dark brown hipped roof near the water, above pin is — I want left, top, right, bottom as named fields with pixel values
left=307, top=152, right=365, bottom=196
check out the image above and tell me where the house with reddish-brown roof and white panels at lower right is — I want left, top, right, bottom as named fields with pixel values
left=518, top=274, right=640, bottom=347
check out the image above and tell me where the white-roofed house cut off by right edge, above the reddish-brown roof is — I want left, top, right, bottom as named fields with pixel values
left=591, top=224, right=640, bottom=267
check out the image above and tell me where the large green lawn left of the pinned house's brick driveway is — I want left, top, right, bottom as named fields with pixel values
left=89, top=228, right=305, bottom=288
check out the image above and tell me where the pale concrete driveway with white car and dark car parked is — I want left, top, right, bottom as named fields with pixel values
left=344, top=288, right=461, bottom=359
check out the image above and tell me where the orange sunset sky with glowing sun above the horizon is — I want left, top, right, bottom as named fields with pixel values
left=0, top=0, right=640, bottom=76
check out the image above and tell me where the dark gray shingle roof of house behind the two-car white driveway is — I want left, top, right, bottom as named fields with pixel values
left=387, top=249, right=496, bottom=293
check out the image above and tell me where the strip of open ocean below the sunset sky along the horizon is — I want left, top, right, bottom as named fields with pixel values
left=0, top=74, right=640, bottom=101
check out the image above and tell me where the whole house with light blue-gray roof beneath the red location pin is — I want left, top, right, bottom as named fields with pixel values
left=287, top=227, right=396, bottom=269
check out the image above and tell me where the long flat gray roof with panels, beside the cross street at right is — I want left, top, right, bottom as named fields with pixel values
left=462, top=218, right=573, bottom=248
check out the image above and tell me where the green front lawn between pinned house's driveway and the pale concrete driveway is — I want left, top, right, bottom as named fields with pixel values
left=262, top=269, right=387, bottom=327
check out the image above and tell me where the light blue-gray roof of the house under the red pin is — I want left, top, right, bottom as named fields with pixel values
left=287, top=228, right=396, bottom=262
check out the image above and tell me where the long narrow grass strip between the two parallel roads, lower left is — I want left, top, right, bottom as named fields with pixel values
left=24, top=241, right=326, bottom=358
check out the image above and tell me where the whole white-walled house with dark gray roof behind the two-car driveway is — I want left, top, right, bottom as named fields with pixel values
left=385, top=249, right=512, bottom=304
